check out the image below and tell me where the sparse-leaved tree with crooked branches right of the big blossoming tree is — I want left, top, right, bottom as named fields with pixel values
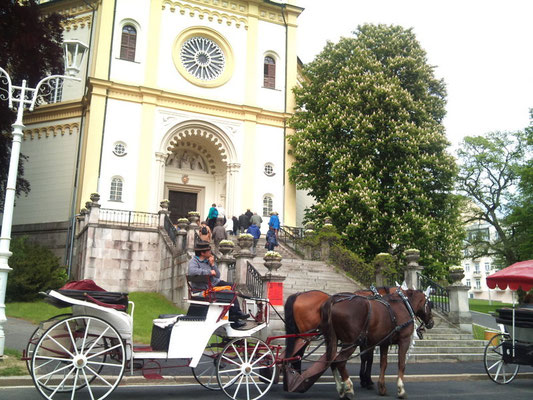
left=457, top=132, right=526, bottom=266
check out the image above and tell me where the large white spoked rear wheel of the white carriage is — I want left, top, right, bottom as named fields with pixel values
left=31, top=315, right=126, bottom=400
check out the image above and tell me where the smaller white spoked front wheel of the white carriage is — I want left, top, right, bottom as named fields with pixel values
left=217, top=337, right=276, bottom=400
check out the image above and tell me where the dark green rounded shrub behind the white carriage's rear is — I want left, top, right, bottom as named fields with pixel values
left=6, top=236, right=67, bottom=301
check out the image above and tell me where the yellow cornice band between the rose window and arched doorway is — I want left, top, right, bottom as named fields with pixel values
left=89, top=78, right=291, bottom=127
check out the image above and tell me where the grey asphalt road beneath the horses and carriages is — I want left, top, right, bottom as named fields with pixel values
left=0, top=379, right=533, bottom=400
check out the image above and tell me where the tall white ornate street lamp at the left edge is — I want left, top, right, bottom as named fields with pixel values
left=0, top=40, right=88, bottom=357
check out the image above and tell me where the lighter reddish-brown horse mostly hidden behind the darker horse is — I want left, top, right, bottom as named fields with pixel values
left=284, top=286, right=397, bottom=389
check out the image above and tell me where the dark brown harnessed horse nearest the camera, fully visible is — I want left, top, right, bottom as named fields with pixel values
left=320, top=288, right=434, bottom=399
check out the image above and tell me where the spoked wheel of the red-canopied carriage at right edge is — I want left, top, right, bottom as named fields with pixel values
left=484, top=333, right=520, bottom=385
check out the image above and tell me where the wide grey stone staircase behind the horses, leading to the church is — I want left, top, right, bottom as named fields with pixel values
left=233, top=237, right=487, bottom=363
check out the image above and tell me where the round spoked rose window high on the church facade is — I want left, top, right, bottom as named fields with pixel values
left=180, top=36, right=225, bottom=81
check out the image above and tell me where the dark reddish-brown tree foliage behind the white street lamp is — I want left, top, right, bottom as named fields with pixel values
left=0, top=0, right=63, bottom=208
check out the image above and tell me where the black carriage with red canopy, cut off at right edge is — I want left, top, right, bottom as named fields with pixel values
left=484, top=260, right=533, bottom=384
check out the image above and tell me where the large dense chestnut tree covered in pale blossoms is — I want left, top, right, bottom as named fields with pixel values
left=289, top=25, right=462, bottom=276
